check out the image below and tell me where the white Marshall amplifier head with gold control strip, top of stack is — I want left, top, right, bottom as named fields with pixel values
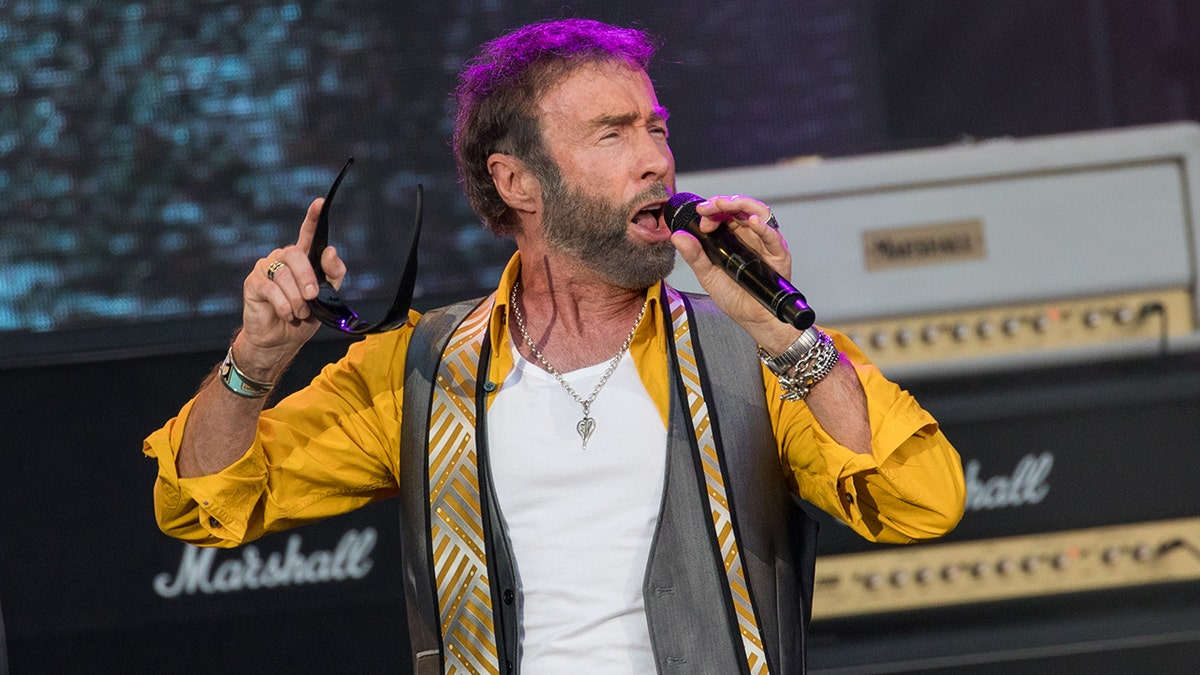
left=670, top=123, right=1200, bottom=375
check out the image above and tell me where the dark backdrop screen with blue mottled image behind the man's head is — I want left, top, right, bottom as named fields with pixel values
left=0, top=0, right=878, bottom=363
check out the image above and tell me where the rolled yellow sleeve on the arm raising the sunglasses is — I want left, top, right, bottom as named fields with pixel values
left=143, top=325, right=412, bottom=546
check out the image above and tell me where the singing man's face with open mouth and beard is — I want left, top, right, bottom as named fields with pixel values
left=538, top=64, right=674, bottom=288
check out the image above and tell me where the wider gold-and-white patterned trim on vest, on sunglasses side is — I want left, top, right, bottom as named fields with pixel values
left=428, top=294, right=500, bottom=675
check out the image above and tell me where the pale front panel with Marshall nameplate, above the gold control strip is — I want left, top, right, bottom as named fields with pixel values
left=763, top=158, right=1190, bottom=322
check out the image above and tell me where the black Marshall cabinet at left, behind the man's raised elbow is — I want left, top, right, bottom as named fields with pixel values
left=0, top=341, right=410, bottom=674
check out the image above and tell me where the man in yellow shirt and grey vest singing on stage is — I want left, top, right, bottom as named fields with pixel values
left=145, top=19, right=965, bottom=675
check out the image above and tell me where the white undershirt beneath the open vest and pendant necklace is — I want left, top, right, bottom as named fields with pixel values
left=487, top=341, right=667, bottom=675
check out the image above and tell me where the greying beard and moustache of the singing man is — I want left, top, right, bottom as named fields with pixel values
left=541, top=172, right=676, bottom=289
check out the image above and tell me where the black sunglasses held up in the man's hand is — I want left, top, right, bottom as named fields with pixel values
left=308, top=157, right=424, bottom=335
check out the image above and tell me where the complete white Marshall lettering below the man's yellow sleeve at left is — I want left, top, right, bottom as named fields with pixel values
left=154, top=527, right=379, bottom=598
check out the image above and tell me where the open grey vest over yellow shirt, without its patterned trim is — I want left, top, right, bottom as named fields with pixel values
left=400, top=294, right=817, bottom=675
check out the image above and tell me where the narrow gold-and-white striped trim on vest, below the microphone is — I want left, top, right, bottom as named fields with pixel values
left=665, top=287, right=768, bottom=675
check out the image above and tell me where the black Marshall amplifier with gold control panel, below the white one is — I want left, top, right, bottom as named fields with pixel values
left=810, top=353, right=1200, bottom=673
